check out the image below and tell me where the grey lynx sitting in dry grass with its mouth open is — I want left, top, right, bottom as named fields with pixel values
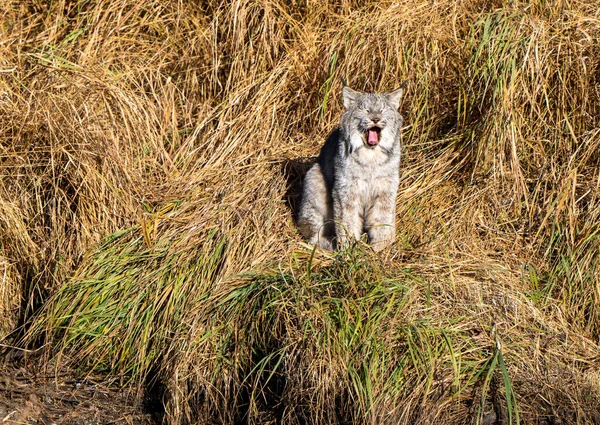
left=298, top=84, right=404, bottom=251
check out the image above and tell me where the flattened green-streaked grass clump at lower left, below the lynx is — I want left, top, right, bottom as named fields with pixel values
left=30, top=227, right=226, bottom=383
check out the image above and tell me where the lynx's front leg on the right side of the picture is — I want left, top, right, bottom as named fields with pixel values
left=365, top=193, right=396, bottom=251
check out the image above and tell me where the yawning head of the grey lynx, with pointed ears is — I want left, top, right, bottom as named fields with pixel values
left=341, top=86, right=404, bottom=153
